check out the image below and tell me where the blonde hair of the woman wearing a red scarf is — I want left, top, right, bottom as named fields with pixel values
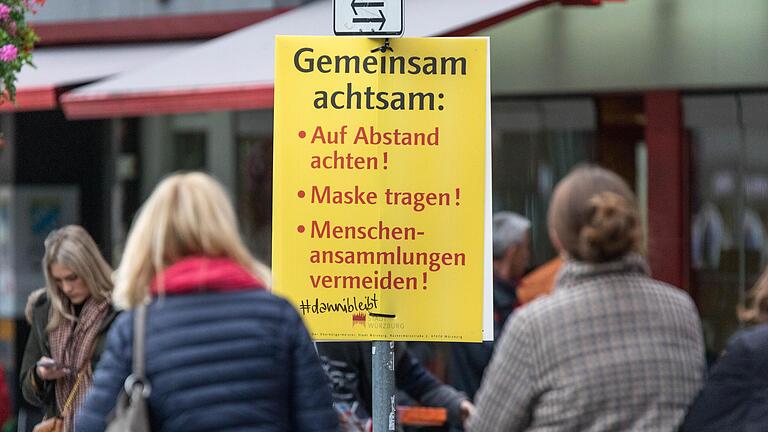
left=113, top=172, right=270, bottom=309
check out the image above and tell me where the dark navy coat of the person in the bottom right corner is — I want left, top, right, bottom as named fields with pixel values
left=683, top=324, right=768, bottom=432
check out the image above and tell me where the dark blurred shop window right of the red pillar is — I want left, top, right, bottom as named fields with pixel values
left=683, top=94, right=768, bottom=356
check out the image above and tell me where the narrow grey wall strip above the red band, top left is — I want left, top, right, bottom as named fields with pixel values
left=31, top=0, right=304, bottom=23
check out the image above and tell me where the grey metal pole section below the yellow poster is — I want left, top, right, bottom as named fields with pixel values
left=371, top=341, right=397, bottom=432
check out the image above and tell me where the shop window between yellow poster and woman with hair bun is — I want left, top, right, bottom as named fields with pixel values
left=492, top=99, right=596, bottom=265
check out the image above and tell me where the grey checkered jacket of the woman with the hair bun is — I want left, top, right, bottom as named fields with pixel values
left=468, top=255, right=705, bottom=432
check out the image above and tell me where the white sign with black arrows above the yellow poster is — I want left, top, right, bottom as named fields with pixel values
left=333, top=0, right=403, bottom=37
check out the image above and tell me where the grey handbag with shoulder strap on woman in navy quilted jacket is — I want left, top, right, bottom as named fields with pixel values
left=105, top=304, right=152, bottom=432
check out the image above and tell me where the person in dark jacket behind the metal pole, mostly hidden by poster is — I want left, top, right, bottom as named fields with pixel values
left=317, top=342, right=475, bottom=430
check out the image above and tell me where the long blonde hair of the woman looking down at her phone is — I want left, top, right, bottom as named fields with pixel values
left=42, top=225, right=112, bottom=331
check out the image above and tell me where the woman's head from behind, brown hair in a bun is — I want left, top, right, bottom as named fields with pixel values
left=548, top=166, right=643, bottom=263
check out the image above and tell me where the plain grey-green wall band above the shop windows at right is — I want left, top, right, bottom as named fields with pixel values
left=481, top=0, right=768, bottom=95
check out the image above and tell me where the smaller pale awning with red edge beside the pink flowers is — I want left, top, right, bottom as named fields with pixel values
left=0, top=42, right=199, bottom=111
